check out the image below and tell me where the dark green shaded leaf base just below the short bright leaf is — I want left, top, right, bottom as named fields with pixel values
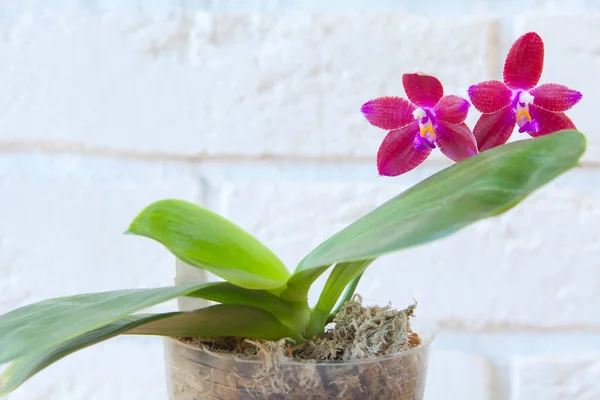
left=188, top=282, right=310, bottom=332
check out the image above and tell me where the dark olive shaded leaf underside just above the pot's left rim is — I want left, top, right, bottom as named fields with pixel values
left=127, top=304, right=303, bottom=341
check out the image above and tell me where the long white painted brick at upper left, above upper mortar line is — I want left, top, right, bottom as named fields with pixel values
left=0, top=11, right=494, bottom=158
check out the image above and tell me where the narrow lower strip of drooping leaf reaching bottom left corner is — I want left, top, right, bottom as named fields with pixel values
left=0, top=314, right=172, bottom=396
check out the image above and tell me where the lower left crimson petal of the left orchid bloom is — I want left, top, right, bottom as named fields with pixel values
left=377, top=121, right=431, bottom=176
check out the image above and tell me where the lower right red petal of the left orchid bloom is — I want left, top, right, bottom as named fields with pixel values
left=436, top=122, right=478, bottom=162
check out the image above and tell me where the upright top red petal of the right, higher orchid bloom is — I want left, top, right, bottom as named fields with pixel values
left=504, top=32, right=544, bottom=90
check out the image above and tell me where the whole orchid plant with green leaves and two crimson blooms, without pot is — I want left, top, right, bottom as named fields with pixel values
left=0, top=33, right=586, bottom=395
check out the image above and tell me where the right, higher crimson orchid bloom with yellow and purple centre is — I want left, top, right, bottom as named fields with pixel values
left=469, top=32, right=582, bottom=151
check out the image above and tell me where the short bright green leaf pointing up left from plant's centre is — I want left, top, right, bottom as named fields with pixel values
left=127, top=200, right=290, bottom=289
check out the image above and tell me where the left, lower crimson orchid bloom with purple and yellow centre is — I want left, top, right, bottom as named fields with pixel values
left=361, top=74, right=477, bottom=176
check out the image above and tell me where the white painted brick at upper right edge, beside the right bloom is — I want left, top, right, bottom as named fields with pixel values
left=513, top=12, right=600, bottom=161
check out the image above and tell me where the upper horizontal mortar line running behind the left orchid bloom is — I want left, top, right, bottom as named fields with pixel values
left=0, top=142, right=600, bottom=169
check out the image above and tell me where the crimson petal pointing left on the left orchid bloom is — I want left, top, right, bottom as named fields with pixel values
left=360, top=97, right=416, bottom=130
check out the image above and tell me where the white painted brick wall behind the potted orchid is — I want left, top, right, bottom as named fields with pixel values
left=0, top=0, right=600, bottom=400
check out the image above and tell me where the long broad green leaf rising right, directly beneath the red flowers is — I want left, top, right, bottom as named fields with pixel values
left=282, top=130, right=586, bottom=300
